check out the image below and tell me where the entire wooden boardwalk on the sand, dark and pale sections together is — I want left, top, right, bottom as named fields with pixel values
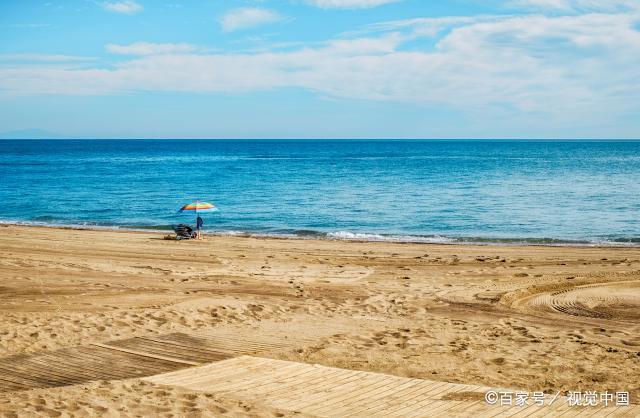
left=0, top=333, right=640, bottom=418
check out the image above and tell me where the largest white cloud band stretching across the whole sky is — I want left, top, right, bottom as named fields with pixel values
left=0, top=13, right=640, bottom=124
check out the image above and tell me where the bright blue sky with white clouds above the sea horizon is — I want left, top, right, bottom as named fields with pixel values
left=0, top=0, right=640, bottom=138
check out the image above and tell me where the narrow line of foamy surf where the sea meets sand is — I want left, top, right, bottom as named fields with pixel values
left=0, top=220, right=640, bottom=249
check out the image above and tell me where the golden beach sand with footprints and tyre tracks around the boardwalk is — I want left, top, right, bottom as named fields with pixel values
left=0, top=225, right=640, bottom=416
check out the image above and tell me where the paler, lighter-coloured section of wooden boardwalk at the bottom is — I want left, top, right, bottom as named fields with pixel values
left=145, top=356, right=640, bottom=418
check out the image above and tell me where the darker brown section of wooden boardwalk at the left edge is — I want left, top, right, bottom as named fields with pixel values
left=0, top=333, right=308, bottom=392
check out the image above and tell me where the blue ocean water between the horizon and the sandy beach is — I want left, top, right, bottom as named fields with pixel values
left=0, top=140, right=640, bottom=245
